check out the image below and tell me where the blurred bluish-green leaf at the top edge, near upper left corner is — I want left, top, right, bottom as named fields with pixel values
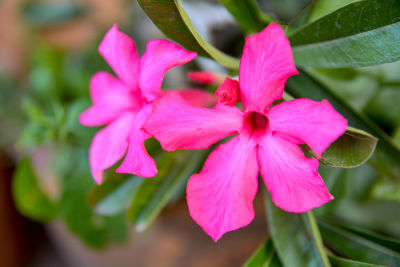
left=22, top=1, right=85, bottom=28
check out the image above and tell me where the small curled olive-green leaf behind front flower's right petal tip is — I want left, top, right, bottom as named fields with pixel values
left=303, top=127, right=378, bottom=168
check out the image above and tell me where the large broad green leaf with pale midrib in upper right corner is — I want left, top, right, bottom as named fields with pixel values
left=289, top=0, right=400, bottom=68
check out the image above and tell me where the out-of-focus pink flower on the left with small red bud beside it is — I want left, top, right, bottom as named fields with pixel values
left=79, top=25, right=213, bottom=184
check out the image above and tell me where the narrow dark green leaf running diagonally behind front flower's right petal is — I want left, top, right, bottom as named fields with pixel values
left=286, top=71, right=400, bottom=179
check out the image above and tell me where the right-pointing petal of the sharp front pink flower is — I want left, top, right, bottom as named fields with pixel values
left=267, top=98, right=347, bottom=157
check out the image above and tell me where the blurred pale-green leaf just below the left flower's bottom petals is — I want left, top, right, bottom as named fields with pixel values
left=89, top=175, right=143, bottom=215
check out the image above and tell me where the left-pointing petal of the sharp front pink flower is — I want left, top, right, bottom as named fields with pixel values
left=144, top=92, right=243, bottom=151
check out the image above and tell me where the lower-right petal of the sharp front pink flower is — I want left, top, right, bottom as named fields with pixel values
left=257, top=134, right=333, bottom=215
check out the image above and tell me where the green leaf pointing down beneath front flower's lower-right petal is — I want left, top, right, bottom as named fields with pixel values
left=266, top=194, right=330, bottom=266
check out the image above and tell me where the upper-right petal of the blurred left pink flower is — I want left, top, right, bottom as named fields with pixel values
left=140, top=40, right=197, bottom=101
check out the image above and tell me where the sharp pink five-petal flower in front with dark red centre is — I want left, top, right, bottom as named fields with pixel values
left=145, top=24, right=347, bottom=240
